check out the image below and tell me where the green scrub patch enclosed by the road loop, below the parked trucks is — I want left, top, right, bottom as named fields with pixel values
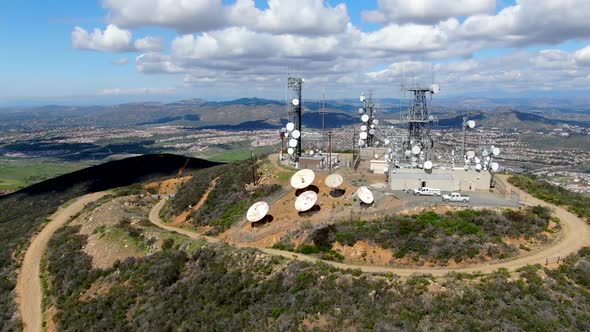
left=275, top=206, right=552, bottom=265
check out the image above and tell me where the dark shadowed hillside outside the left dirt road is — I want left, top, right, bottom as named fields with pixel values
left=0, top=154, right=217, bottom=331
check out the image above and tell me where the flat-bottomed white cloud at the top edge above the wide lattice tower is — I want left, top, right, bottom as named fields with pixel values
left=362, top=0, right=496, bottom=24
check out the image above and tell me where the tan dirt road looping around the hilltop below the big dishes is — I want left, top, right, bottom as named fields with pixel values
left=150, top=179, right=590, bottom=277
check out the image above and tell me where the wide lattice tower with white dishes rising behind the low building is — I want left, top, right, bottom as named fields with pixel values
left=402, top=84, right=440, bottom=164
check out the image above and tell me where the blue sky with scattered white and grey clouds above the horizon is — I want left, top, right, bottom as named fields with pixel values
left=0, top=0, right=590, bottom=105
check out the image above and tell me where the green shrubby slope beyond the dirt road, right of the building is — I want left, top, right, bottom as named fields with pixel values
left=508, top=175, right=590, bottom=223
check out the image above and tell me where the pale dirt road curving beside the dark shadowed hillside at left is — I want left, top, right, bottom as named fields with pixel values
left=16, top=192, right=106, bottom=332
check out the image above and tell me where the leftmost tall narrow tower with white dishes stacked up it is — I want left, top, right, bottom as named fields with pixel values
left=285, top=77, right=304, bottom=161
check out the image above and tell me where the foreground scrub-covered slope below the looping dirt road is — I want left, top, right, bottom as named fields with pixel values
left=46, top=227, right=590, bottom=331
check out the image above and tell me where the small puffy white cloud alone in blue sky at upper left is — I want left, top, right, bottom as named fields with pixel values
left=72, top=24, right=134, bottom=52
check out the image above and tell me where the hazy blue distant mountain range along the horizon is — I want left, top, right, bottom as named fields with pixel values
left=0, top=98, right=590, bottom=130
